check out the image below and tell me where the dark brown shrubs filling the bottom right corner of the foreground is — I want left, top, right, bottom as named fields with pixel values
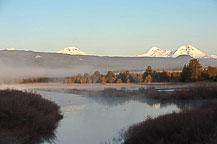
left=124, top=100, right=217, bottom=144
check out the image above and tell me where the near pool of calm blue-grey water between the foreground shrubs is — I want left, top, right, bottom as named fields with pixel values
left=37, top=90, right=179, bottom=144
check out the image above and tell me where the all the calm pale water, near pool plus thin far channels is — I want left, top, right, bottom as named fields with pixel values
left=0, top=85, right=205, bottom=144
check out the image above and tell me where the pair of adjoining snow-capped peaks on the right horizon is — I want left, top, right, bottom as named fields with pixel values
left=138, top=45, right=217, bottom=58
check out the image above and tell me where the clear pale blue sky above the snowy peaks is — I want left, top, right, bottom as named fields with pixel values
left=0, top=0, right=217, bottom=56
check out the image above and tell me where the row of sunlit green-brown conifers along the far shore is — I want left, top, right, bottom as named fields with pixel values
left=19, top=59, right=217, bottom=84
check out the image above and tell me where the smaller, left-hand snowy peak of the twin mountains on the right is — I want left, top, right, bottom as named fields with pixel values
left=138, top=47, right=171, bottom=57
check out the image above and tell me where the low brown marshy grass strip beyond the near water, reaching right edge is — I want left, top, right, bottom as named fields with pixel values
left=59, top=84, right=217, bottom=101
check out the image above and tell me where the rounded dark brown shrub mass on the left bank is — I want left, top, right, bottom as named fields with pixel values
left=0, top=90, right=63, bottom=143
